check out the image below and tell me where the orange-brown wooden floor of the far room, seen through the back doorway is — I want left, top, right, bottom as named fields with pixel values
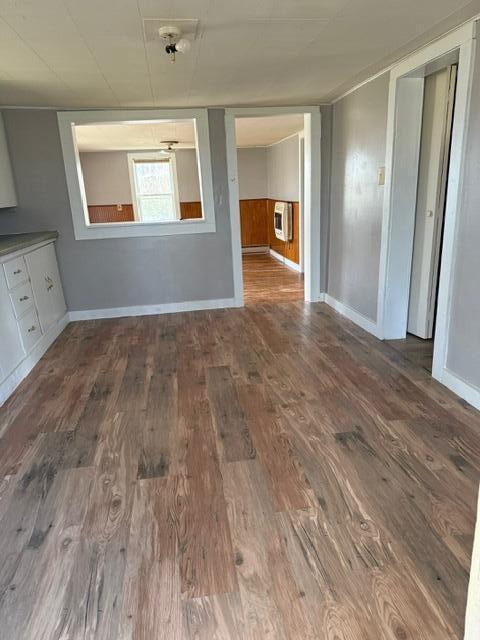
left=242, top=253, right=304, bottom=305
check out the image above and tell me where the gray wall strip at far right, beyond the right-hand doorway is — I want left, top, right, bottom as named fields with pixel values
left=447, top=42, right=480, bottom=388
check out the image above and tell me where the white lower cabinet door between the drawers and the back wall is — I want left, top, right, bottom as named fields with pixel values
left=25, top=243, right=66, bottom=333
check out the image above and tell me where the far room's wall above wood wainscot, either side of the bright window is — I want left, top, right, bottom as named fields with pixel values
left=80, top=149, right=200, bottom=205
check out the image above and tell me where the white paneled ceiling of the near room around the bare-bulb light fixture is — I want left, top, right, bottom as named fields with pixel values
left=0, top=0, right=480, bottom=108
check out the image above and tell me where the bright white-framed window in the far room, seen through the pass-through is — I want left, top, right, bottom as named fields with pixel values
left=128, top=151, right=181, bottom=222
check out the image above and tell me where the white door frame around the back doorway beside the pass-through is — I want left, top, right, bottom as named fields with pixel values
left=225, top=106, right=322, bottom=307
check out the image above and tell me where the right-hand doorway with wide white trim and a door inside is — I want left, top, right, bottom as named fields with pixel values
left=377, top=25, right=475, bottom=395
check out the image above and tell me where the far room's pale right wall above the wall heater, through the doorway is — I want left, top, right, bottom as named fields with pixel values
left=267, top=136, right=300, bottom=202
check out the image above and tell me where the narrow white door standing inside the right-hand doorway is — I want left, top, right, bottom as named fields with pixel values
left=408, top=66, right=456, bottom=338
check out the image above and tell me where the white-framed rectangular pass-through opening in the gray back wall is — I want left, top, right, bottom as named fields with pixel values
left=58, top=109, right=216, bottom=240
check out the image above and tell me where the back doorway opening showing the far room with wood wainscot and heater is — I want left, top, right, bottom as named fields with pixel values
left=235, top=114, right=304, bottom=305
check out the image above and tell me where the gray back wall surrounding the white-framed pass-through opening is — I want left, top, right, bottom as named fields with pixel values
left=0, top=109, right=233, bottom=310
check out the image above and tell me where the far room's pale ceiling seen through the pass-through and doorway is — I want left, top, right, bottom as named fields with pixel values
left=75, top=114, right=303, bottom=152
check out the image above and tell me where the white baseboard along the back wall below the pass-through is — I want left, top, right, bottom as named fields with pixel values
left=69, top=298, right=241, bottom=322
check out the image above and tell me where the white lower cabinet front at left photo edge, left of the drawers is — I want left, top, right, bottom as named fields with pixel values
left=0, top=265, right=25, bottom=380
